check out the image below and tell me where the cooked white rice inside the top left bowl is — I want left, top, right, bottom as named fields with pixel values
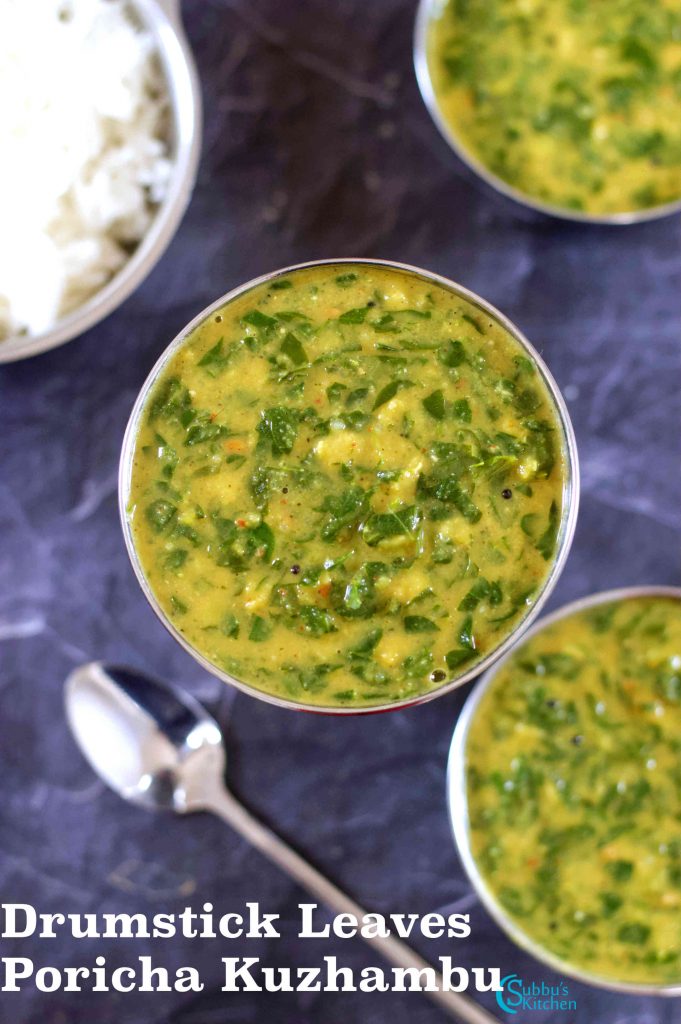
left=0, top=0, right=171, bottom=340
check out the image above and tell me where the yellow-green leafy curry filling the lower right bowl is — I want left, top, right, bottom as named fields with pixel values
left=466, top=597, right=681, bottom=985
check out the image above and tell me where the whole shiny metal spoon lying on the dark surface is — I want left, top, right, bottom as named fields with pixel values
left=65, top=662, right=499, bottom=1024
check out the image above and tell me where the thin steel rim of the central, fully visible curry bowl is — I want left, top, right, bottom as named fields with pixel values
left=119, top=259, right=580, bottom=715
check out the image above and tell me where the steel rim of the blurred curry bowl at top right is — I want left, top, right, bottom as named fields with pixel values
left=414, top=0, right=681, bottom=225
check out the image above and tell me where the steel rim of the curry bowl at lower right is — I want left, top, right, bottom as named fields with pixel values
left=446, top=586, right=681, bottom=995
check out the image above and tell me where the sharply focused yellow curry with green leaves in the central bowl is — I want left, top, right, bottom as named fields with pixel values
left=124, top=264, right=565, bottom=706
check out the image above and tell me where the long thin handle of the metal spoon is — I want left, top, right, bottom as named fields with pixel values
left=196, top=790, right=499, bottom=1024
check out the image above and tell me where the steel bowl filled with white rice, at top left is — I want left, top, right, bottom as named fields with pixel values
left=0, top=0, right=201, bottom=362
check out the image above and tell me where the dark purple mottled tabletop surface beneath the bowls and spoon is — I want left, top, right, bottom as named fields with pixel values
left=0, top=0, right=681, bottom=1024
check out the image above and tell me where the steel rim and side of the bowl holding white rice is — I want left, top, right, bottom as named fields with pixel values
left=0, top=0, right=202, bottom=362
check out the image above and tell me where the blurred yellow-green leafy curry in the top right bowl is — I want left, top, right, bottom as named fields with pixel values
left=428, top=0, right=681, bottom=214
